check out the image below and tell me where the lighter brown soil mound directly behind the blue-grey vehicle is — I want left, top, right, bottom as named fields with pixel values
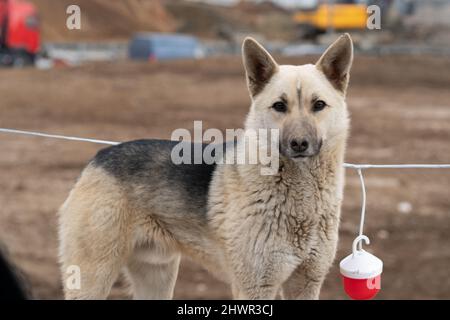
left=31, top=0, right=176, bottom=42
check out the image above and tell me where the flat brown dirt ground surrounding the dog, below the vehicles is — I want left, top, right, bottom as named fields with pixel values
left=0, top=56, right=450, bottom=299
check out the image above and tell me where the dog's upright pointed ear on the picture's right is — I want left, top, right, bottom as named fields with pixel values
left=316, top=33, right=353, bottom=95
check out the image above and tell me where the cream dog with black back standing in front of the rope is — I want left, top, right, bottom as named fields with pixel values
left=59, top=34, right=353, bottom=299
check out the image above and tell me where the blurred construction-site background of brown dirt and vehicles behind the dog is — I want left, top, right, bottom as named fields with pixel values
left=0, top=0, right=450, bottom=299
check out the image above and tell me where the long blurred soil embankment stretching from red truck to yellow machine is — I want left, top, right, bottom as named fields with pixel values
left=30, top=0, right=295, bottom=42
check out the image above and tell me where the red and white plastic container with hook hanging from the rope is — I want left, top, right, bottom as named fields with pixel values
left=339, top=235, right=383, bottom=300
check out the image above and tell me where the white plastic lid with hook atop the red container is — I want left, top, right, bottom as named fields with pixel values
left=339, top=235, right=383, bottom=279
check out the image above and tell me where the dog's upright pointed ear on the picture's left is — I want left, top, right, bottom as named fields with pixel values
left=242, top=38, right=278, bottom=96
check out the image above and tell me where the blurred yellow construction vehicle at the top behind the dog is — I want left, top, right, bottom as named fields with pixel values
left=293, top=0, right=367, bottom=38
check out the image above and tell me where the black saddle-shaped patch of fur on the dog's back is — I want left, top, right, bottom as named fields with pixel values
left=92, top=140, right=221, bottom=213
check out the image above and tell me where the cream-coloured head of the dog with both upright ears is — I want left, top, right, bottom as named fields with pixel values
left=243, top=34, right=353, bottom=159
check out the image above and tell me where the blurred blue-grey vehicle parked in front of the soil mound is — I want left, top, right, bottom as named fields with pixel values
left=128, top=33, right=205, bottom=61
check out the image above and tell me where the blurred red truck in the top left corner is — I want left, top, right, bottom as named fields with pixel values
left=0, top=0, right=40, bottom=66
